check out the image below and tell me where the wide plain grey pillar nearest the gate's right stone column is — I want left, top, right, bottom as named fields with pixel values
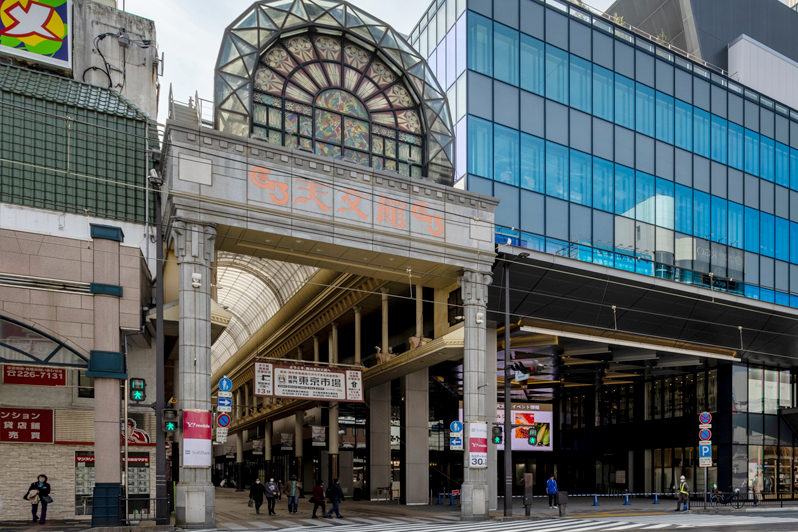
left=401, top=368, right=429, bottom=504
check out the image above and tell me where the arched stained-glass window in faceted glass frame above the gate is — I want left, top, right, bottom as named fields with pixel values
left=215, top=0, right=454, bottom=183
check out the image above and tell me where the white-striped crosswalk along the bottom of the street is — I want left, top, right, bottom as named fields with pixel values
left=217, top=514, right=798, bottom=532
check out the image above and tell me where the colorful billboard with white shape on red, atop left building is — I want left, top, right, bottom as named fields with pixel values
left=0, top=0, right=72, bottom=70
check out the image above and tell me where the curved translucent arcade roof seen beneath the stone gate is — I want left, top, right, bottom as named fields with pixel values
left=211, top=251, right=318, bottom=373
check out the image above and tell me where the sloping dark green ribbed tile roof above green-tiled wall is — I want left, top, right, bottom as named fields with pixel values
left=0, top=65, right=147, bottom=120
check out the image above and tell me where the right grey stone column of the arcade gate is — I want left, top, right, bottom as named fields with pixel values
left=458, top=270, right=496, bottom=520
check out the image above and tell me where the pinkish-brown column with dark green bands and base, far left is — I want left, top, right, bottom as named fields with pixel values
left=90, top=226, right=123, bottom=526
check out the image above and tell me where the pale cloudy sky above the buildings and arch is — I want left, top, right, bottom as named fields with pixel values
left=123, top=0, right=612, bottom=122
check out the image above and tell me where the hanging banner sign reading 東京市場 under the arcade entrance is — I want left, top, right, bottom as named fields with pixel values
left=253, top=362, right=363, bottom=403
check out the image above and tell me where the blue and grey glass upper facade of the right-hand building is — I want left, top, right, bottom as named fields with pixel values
left=411, top=0, right=798, bottom=307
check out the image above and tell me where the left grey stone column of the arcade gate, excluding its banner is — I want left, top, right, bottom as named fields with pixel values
left=172, top=219, right=216, bottom=528
